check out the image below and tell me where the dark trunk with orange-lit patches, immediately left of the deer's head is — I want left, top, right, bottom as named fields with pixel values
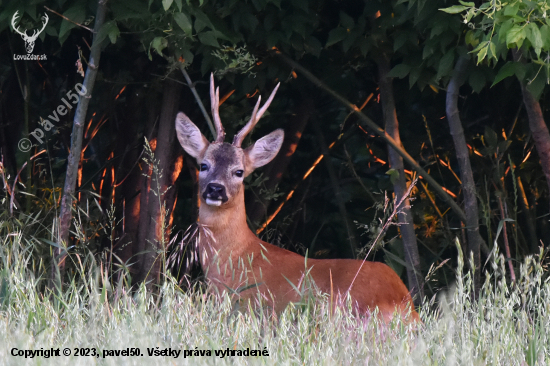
left=136, top=79, right=183, bottom=289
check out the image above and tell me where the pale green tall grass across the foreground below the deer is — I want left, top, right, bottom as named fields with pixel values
left=0, top=229, right=550, bottom=365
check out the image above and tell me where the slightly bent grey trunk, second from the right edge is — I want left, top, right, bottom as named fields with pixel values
left=446, top=56, right=488, bottom=298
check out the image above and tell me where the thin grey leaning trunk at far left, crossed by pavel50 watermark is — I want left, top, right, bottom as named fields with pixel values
left=51, top=0, right=107, bottom=281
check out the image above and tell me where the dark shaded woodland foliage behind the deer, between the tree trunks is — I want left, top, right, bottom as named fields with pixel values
left=0, top=0, right=550, bottom=304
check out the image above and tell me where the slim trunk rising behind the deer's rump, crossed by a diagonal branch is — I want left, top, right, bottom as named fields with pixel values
left=377, top=54, right=424, bottom=305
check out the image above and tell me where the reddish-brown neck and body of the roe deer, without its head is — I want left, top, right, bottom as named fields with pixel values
left=199, top=184, right=418, bottom=321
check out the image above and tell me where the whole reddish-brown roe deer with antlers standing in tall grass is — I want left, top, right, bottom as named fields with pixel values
left=176, top=75, right=418, bottom=321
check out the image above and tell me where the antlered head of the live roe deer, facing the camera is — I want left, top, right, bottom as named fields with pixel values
left=176, top=74, right=284, bottom=207
